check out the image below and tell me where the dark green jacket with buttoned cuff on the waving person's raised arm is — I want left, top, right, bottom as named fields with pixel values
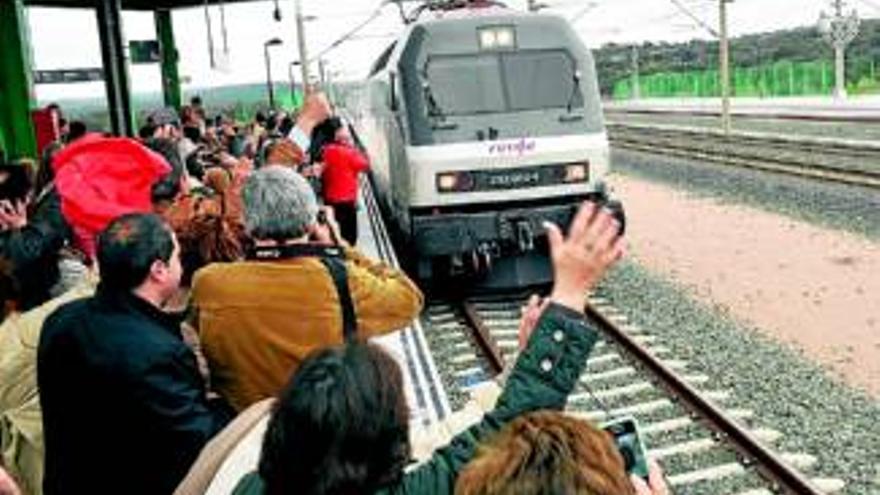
left=233, top=304, right=597, bottom=495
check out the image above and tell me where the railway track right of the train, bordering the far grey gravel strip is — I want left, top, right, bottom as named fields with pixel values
left=608, top=123, right=880, bottom=188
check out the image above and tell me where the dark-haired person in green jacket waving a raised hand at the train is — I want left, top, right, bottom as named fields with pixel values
left=223, top=203, right=632, bottom=495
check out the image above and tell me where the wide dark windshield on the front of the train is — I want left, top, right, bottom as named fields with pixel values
left=423, top=50, right=584, bottom=115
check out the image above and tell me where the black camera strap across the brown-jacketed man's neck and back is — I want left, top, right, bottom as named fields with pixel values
left=247, top=244, right=357, bottom=342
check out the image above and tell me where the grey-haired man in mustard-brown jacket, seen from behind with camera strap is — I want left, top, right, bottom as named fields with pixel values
left=192, top=166, right=423, bottom=411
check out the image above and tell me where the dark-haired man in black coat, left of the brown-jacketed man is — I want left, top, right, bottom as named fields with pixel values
left=37, top=214, right=231, bottom=495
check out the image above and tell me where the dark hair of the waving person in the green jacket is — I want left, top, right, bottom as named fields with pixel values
left=259, top=342, right=410, bottom=495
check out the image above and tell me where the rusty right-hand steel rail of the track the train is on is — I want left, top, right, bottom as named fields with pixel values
left=586, top=304, right=822, bottom=495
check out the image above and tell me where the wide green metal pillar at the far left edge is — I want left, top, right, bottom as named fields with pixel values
left=0, top=0, right=37, bottom=158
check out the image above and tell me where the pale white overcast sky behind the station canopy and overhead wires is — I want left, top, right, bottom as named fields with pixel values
left=29, top=0, right=880, bottom=99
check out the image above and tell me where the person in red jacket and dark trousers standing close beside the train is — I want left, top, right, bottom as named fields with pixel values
left=316, top=117, right=370, bottom=246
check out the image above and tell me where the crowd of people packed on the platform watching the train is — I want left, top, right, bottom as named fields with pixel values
left=0, top=93, right=667, bottom=495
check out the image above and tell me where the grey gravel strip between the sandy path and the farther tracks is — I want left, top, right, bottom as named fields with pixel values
left=611, top=149, right=880, bottom=239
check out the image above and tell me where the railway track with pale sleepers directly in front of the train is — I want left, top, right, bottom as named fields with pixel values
left=422, top=296, right=845, bottom=495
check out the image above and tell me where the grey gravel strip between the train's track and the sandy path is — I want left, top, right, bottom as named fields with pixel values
left=598, top=262, right=880, bottom=495
